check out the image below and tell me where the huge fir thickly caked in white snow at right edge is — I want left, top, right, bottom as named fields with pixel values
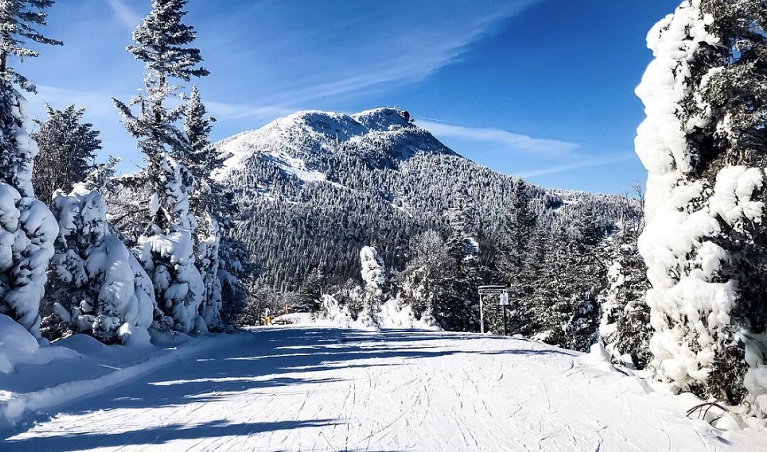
left=636, top=0, right=767, bottom=413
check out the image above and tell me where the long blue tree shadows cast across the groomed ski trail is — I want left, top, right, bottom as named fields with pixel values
left=0, top=328, right=575, bottom=451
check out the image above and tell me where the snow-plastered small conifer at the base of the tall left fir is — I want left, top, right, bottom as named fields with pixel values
left=134, top=156, right=205, bottom=333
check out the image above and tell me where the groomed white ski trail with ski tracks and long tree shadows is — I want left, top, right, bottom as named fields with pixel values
left=0, top=328, right=767, bottom=452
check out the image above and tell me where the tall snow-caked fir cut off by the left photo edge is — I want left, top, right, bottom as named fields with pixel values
left=0, top=0, right=61, bottom=336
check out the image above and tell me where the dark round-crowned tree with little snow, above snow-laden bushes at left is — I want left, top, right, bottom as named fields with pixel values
left=30, top=105, right=101, bottom=205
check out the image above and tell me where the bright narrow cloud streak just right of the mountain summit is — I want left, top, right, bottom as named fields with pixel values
left=418, top=120, right=578, bottom=157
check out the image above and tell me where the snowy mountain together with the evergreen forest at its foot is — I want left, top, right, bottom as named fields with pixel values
left=204, top=108, right=641, bottom=360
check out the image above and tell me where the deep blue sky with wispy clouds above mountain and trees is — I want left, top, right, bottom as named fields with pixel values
left=24, top=0, right=679, bottom=193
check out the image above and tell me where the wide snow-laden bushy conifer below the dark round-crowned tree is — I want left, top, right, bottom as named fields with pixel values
left=47, top=184, right=156, bottom=343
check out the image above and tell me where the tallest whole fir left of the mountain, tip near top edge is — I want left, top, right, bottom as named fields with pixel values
left=114, top=0, right=210, bottom=333
